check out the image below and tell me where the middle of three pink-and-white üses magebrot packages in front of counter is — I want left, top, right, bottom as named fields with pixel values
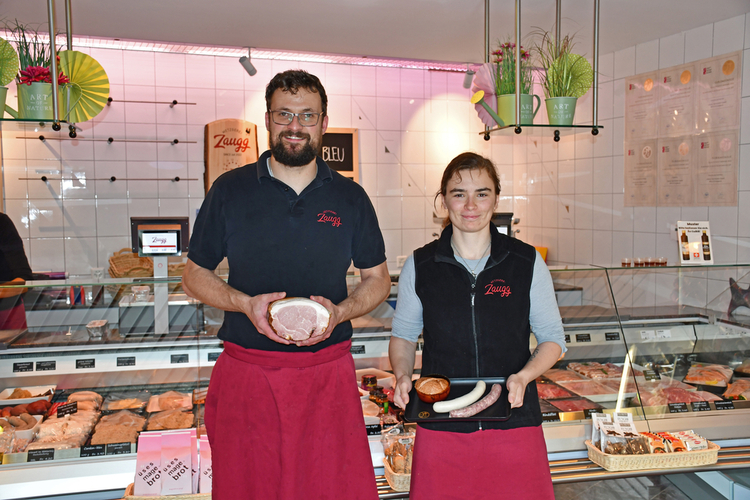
left=161, top=431, right=193, bottom=495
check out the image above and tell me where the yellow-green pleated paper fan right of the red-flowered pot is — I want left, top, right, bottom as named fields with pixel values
left=58, top=50, right=109, bottom=123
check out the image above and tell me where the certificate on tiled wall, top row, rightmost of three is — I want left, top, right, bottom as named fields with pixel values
left=696, top=52, right=742, bottom=133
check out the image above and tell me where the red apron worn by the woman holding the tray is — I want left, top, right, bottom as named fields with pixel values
left=409, top=426, right=555, bottom=500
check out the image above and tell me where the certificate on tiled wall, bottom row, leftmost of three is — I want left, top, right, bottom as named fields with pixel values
left=623, top=140, right=657, bottom=207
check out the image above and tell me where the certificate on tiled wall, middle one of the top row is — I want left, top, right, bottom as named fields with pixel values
left=658, top=63, right=697, bottom=137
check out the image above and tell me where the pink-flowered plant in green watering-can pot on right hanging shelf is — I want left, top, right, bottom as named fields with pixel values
left=492, top=41, right=541, bottom=126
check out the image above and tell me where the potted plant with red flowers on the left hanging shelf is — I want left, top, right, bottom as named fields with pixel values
left=5, top=20, right=68, bottom=120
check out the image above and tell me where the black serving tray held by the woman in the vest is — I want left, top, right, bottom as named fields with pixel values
left=404, top=377, right=510, bottom=422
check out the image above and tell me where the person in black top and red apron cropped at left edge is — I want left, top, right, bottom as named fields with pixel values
left=0, top=212, right=31, bottom=330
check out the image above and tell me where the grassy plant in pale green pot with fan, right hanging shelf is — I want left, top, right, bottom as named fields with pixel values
left=536, top=31, right=594, bottom=126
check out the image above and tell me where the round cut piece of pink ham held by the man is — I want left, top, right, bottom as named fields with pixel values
left=268, top=297, right=331, bottom=341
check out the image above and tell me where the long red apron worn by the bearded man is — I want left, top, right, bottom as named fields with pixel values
left=205, top=342, right=378, bottom=500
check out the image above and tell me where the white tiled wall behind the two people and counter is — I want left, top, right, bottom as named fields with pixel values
left=2, top=15, right=750, bottom=282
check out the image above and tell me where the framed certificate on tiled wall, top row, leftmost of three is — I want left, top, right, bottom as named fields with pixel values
left=625, top=72, right=659, bottom=141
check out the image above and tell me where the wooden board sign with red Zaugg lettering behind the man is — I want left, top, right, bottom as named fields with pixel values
left=203, top=118, right=258, bottom=193
